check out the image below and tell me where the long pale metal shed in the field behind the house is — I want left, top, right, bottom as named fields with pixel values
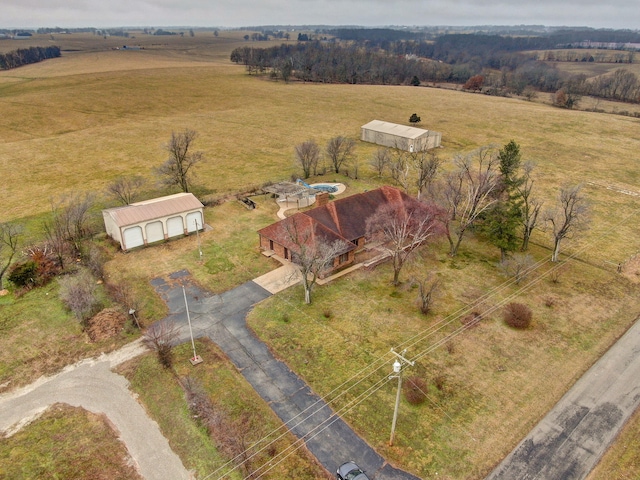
left=361, top=120, right=442, bottom=152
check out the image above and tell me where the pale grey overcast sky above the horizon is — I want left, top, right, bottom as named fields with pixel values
left=0, top=0, right=640, bottom=30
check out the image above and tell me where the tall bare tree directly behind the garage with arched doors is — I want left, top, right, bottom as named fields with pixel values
left=156, top=129, right=203, bottom=193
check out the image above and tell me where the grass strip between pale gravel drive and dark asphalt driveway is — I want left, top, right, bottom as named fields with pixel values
left=119, top=339, right=324, bottom=480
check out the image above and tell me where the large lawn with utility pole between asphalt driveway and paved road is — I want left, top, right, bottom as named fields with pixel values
left=250, top=234, right=640, bottom=479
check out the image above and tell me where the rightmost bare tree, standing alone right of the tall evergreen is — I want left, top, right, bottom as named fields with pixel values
left=544, top=185, right=589, bottom=262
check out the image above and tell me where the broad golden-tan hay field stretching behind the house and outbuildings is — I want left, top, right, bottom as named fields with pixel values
left=0, top=32, right=640, bottom=261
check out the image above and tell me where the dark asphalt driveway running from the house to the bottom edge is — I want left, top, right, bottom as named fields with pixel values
left=152, top=272, right=417, bottom=480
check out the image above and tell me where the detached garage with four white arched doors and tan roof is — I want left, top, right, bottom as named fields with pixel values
left=102, top=193, right=204, bottom=251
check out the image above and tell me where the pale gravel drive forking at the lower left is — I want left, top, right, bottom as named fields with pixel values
left=0, top=341, right=192, bottom=480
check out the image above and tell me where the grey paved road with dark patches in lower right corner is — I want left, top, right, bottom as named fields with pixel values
left=487, top=316, right=640, bottom=480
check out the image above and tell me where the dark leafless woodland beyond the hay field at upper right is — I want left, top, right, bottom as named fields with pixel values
left=230, top=34, right=640, bottom=107
